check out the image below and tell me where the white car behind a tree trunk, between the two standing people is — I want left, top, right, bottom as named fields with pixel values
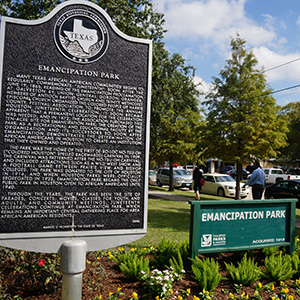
left=201, top=173, right=249, bottom=198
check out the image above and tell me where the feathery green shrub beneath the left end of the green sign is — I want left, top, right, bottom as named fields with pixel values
left=192, top=257, right=222, bottom=291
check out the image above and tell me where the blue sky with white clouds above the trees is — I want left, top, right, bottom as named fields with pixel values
left=153, top=0, right=300, bottom=106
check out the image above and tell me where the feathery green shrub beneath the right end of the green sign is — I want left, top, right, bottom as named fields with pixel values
left=264, top=251, right=297, bottom=282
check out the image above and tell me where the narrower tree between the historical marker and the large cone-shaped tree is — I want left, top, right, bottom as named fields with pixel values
left=156, top=54, right=201, bottom=191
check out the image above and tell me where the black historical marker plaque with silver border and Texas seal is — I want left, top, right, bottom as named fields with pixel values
left=0, top=1, right=152, bottom=252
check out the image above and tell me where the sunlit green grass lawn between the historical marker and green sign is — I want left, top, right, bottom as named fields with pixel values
left=127, top=187, right=300, bottom=247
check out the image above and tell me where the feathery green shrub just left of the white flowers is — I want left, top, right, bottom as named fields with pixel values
left=119, top=253, right=150, bottom=281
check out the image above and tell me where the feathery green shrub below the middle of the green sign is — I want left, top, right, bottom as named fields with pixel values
left=225, top=254, right=262, bottom=286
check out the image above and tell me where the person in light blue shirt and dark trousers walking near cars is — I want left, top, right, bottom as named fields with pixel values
left=245, top=161, right=266, bottom=200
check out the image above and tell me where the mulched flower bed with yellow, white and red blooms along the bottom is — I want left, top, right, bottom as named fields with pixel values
left=0, top=241, right=300, bottom=300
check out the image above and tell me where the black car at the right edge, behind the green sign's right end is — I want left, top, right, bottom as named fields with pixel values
left=265, top=180, right=300, bottom=207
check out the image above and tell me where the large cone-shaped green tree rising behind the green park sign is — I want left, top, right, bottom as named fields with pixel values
left=205, top=35, right=287, bottom=198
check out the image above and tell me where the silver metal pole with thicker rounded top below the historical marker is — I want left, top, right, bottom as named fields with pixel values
left=60, top=239, right=87, bottom=300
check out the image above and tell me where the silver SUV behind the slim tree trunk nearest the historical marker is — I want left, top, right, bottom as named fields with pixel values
left=156, top=168, right=193, bottom=190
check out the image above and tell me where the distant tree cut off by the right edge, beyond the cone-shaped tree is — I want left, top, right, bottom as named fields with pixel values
left=281, top=102, right=300, bottom=162
